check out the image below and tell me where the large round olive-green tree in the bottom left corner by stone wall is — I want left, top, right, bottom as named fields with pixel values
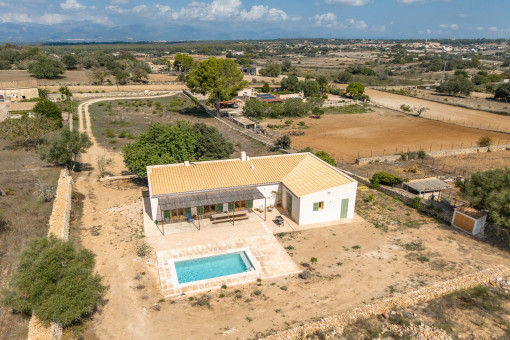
left=2, top=236, right=107, bottom=327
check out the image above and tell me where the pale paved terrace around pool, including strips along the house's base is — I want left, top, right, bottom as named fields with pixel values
left=144, top=197, right=363, bottom=297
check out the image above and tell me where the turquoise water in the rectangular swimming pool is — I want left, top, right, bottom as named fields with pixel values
left=175, top=251, right=253, bottom=283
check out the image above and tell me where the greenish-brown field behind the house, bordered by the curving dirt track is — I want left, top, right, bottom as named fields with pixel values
left=89, top=94, right=273, bottom=157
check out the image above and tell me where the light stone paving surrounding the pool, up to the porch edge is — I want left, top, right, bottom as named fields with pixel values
left=153, top=221, right=300, bottom=297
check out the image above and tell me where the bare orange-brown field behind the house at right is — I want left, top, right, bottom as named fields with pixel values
left=263, top=107, right=510, bottom=162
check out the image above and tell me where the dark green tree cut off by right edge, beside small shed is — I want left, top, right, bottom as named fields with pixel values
left=461, top=168, right=510, bottom=229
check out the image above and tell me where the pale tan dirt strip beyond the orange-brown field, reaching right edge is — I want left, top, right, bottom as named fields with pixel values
left=366, top=89, right=510, bottom=132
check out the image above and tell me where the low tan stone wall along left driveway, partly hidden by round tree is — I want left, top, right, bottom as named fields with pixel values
left=27, top=169, right=73, bottom=340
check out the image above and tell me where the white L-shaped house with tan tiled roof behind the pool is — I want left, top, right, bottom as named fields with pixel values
left=147, top=152, right=357, bottom=225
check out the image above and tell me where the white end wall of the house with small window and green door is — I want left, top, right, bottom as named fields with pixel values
left=297, top=182, right=358, bottom=225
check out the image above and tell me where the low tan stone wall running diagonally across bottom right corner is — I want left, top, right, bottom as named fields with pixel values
left=264, top=265, right=510, bottom=340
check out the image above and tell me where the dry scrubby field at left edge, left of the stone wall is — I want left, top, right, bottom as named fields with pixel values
left=0, top=140, right=60, bottom=339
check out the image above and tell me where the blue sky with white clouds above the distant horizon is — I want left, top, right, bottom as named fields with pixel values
left=0, top=0, right=510, bottom=41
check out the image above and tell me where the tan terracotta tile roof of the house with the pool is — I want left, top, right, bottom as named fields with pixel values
left=147, top=153, right=353, bottom=197
